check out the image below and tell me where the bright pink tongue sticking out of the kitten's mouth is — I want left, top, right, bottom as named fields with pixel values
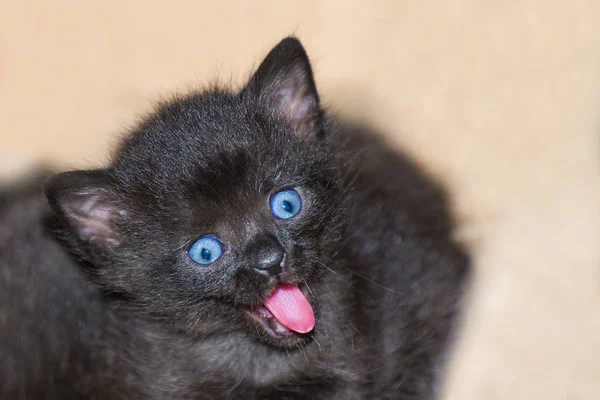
left=265, top=284, right=315, bottom=333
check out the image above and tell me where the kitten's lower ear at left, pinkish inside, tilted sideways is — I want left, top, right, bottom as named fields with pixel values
left=46, top=170, right=124, bottom=248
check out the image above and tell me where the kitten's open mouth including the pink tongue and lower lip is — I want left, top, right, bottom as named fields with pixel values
left=250, top=283, right=315, bottom=340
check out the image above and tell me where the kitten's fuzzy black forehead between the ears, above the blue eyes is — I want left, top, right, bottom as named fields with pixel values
left=115, top=93, right=324, bottom=197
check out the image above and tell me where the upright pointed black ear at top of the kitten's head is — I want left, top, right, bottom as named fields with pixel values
left=244, top=37, right=322, bottom=137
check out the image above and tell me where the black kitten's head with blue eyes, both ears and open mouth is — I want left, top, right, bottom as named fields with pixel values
left=46, top=38, right=341, bottom=347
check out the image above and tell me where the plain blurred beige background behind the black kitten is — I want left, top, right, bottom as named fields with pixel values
left=0, top=0, right=600, bottom=400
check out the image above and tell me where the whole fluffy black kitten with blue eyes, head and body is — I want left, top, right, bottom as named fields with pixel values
left=0, top=38, right=468, bottom=400
